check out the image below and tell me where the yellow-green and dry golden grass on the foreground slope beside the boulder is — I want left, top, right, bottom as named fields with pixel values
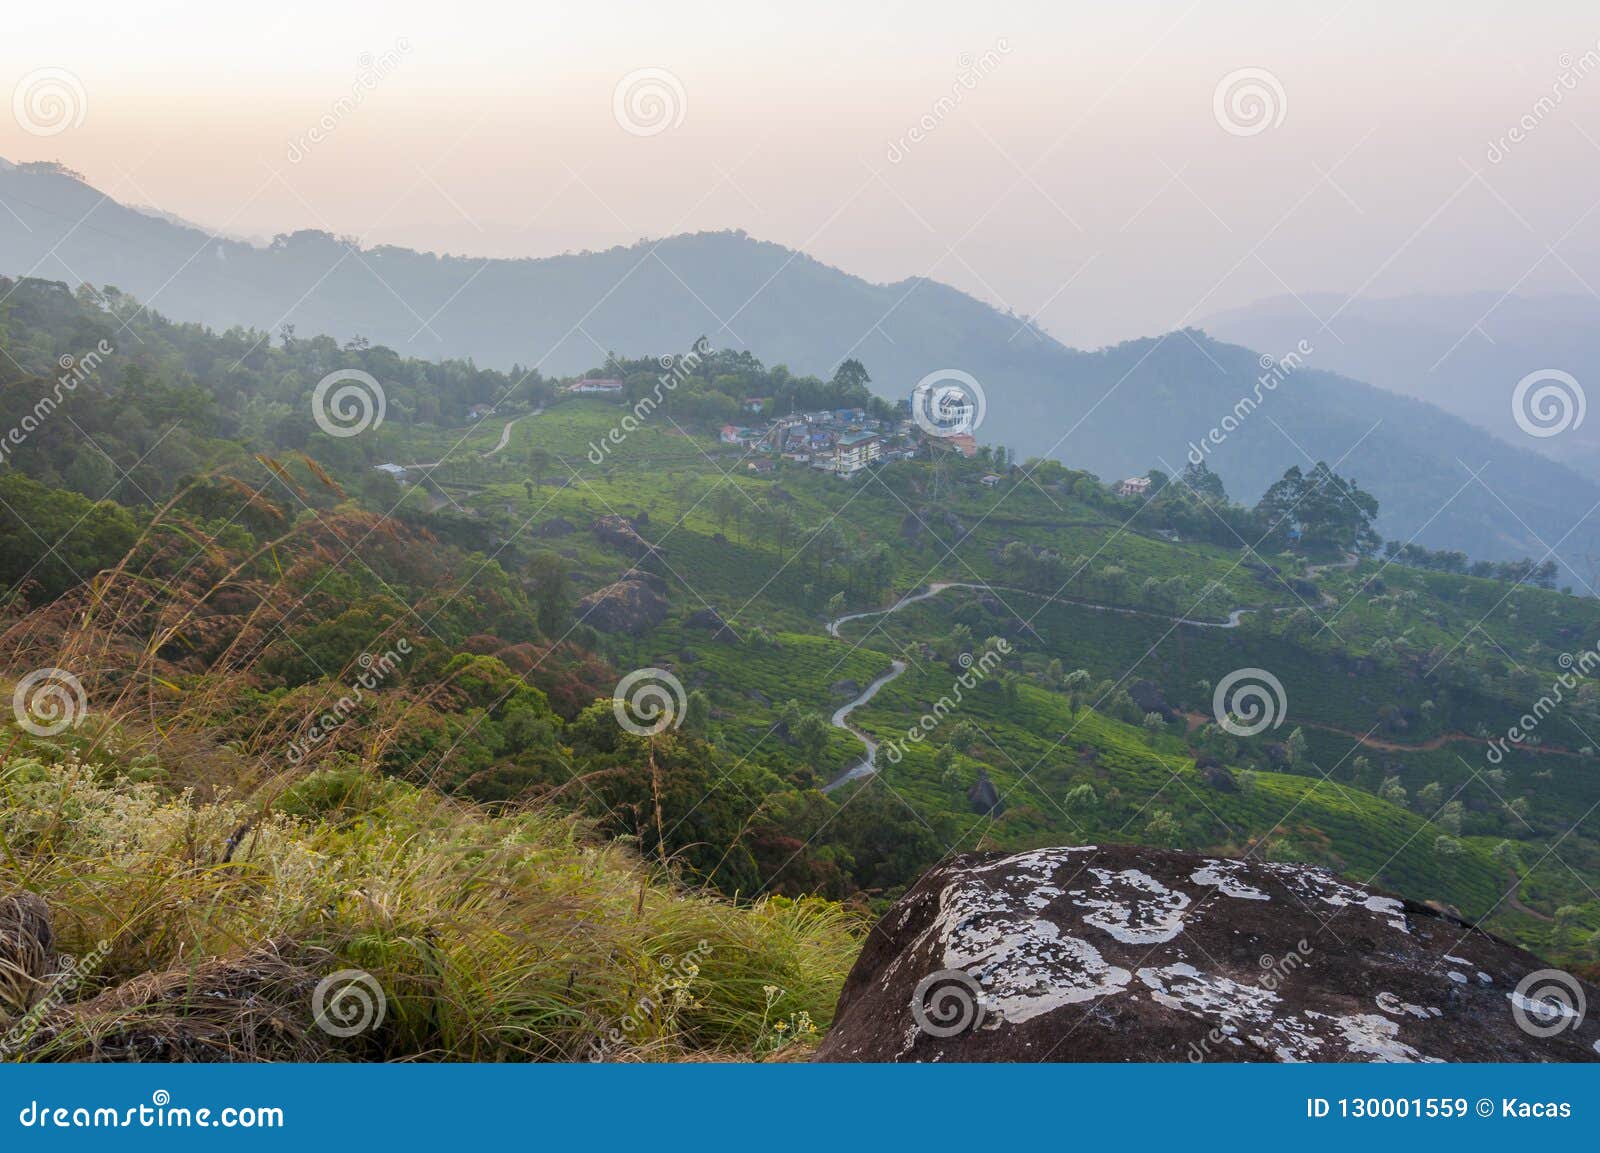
left=0, top=476, right=861, bottom=1060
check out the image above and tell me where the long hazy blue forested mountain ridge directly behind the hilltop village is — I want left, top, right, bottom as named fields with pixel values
left=9, top=155, right=1600, bottom=579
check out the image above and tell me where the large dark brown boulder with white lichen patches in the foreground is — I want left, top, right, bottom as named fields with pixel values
left=818, top=846, right=1600, bottom=1062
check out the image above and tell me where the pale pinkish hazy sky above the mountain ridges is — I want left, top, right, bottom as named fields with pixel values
left=0, top=0, right=1600, bottom=345
